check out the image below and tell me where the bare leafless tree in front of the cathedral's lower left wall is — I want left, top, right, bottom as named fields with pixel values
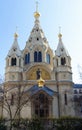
left=0, top=84, right=30, bottom=130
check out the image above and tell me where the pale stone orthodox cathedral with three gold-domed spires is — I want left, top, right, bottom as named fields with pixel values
left=4, top=7, right=74, bottom=118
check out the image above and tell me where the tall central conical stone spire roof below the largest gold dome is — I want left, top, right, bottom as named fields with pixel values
left=25, top=11, right=49, bottom=49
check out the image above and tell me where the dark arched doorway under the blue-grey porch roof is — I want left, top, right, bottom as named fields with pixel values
left=33, top=92, right=50, bottom=117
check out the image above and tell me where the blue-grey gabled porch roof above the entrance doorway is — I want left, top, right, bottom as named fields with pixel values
left=28, top=85, right=57, bottom=96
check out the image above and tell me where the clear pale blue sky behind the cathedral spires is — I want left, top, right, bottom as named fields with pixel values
left=0, top=0, right=82, bottom=83
